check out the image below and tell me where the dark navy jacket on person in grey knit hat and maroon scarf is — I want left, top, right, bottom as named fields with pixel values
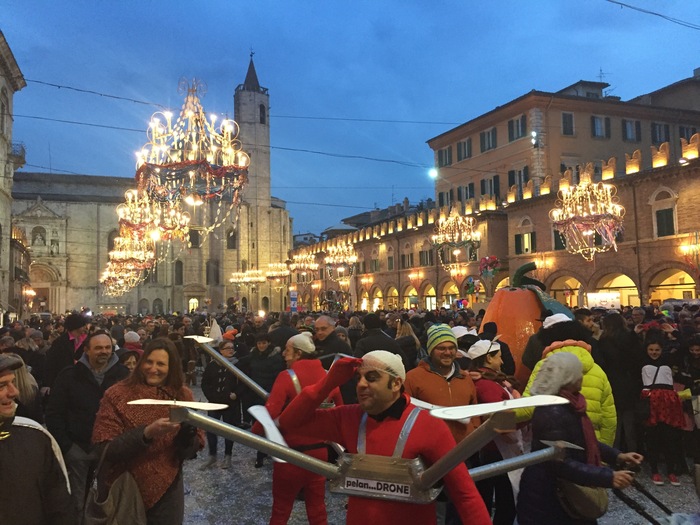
left=518, top=404, right=619, bottom=525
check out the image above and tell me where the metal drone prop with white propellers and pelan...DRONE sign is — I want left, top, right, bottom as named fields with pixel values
left=139, top=336, right=580, bottom=503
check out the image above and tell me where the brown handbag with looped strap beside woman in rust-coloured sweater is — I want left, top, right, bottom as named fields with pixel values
left=83, top=444, right=146, bottom=525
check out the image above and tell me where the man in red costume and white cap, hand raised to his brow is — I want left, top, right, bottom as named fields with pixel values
left=279, top=350, right=491, bottom=525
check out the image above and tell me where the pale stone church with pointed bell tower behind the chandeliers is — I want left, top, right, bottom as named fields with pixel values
left=12, top=57, right=292, bottom=314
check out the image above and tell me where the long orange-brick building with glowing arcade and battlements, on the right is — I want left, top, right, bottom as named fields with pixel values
left=288, top=70, right=700, bottom=309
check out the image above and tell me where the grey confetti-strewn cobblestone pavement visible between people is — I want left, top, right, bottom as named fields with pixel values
left=184, top=382, right=700, bottom=525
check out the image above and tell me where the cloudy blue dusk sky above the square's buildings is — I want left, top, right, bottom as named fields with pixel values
left=0, top=0, right=700, bottom=233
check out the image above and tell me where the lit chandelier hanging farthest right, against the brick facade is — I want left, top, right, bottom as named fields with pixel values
left=549, top=169, right=625, bottom=261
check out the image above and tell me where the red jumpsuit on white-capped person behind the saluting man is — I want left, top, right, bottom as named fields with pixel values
left=253, top=359, right=343, bottom=525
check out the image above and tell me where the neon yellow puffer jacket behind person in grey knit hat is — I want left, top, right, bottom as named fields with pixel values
left=516, top=340, right=617, bottom=446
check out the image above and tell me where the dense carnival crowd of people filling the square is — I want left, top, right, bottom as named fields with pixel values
left=0, top=305, right=700, bottom=524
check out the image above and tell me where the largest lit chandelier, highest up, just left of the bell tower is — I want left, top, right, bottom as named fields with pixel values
left=136, top=79, right=250, bottom=239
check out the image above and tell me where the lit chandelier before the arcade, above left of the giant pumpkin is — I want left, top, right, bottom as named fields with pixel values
left=431, top=207, right=481, bottom=270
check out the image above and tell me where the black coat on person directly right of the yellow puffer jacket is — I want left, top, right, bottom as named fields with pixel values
left=599, top=332, right=644, bottom=413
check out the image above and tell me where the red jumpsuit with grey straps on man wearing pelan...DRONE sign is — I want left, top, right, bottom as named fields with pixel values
left=280, top=388, right=491, bottom=525
